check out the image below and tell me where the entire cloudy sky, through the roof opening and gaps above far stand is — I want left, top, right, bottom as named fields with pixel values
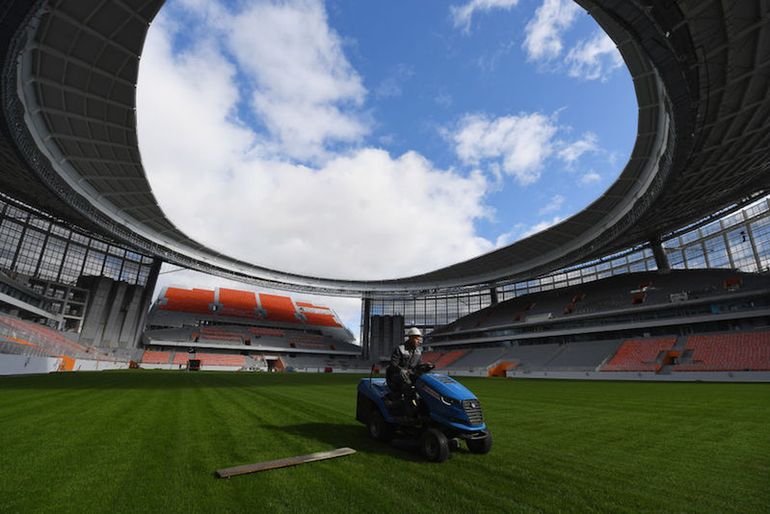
left=137, top=0, right=636, bottom=334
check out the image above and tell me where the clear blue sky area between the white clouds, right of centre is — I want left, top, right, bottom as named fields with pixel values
left=327, top=0, right=636, bottom=240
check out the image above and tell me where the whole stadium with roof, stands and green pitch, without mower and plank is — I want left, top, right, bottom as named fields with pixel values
left=0, top=0, right=770, bottom=512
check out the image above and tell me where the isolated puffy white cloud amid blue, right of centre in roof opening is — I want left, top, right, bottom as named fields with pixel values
left=450, top=113, right=558, bottom=185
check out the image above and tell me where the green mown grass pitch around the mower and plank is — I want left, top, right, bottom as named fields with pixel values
left=0, top=370, right=770, bottom=513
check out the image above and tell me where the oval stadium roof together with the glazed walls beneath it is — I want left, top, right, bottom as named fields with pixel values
left=0, top=0, right=770, bottom=376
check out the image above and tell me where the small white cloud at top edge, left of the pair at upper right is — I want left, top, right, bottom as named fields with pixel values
left=523, top=0, right=580, bottom=61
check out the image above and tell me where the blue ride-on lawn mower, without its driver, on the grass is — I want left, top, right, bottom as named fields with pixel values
left=356, top=364, right=492, bottom=462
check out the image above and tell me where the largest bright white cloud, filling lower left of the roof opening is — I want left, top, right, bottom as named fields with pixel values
left=137, top=10, right=493, bottom=279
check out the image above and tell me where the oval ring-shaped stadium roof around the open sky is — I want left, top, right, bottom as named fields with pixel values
left=0, top=0, right=770, bottom=295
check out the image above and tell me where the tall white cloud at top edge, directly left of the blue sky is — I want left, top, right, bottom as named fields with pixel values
left=219, top=0, right=369, bottom=160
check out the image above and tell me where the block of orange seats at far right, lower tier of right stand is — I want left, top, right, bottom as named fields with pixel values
left=673, top=332, right=770, bottom=371
